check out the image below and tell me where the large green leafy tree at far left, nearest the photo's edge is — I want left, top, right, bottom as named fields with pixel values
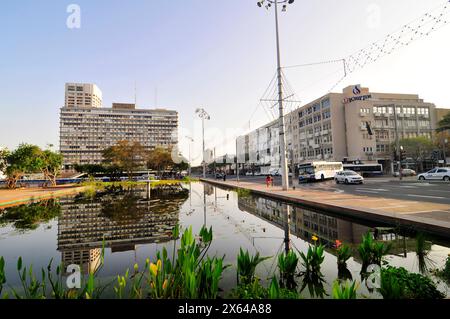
left=6, top=144, right=42, bottom=189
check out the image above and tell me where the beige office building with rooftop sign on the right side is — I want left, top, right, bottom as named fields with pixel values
left=239, top=85, right=436, bottom=171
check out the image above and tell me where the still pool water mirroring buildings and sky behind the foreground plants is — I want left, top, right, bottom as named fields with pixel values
left=0, top=183, right=450, bottom=298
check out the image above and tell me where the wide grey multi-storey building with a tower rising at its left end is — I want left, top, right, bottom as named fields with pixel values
left=60, top=84, right=178, bottom=168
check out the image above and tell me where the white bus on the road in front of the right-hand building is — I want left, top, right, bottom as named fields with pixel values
left=298, top=162, right=344, bottom=183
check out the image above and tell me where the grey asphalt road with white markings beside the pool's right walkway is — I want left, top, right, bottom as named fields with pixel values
left=208, top=176, right=450, bottom=204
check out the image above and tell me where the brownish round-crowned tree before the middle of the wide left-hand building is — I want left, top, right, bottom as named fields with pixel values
left=103, top=141, right=146, bottom=180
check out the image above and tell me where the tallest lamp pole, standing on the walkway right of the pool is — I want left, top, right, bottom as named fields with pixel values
left=257, top=0, right=294, bottom=190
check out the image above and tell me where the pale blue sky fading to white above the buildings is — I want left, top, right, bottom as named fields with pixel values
left=0, top=0, right=450, bottom=165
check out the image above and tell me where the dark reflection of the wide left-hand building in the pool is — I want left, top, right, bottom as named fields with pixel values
left=58, top=189, right=189, bottom=273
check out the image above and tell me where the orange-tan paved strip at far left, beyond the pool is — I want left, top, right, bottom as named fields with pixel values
left=0, top=185, right=85, bottom=209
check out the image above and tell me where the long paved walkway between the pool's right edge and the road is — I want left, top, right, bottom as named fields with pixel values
left=201, top=179, right=450, bottom=239
